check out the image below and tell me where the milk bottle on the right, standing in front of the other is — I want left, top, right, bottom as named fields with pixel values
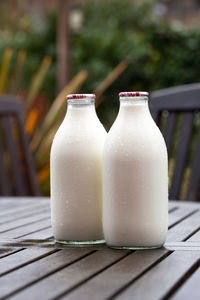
left=103, top=92, right=168, bottom=249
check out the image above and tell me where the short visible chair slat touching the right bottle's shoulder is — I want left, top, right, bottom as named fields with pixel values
left=163, top=112, right=176, bottom=156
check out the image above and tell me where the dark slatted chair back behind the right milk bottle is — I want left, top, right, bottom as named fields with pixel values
left=150, top=83, right=200, bottom=201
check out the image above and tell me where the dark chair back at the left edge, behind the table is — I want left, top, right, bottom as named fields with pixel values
left=0, top=95, right=40, bottom=196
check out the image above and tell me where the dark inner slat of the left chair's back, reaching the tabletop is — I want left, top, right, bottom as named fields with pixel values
left=2, top=116, right=26, bottom=196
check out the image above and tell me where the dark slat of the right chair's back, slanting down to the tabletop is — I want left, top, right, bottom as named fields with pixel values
left=169, top=112, right=194, bottom=199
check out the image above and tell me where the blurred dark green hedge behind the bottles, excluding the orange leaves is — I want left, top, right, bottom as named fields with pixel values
left=0, top=0, right=200, bottom=124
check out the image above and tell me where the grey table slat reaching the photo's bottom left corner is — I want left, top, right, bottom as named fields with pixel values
left=0, top=249, right=91, bottom=299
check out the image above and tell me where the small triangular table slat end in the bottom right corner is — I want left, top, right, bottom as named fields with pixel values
left=171, top=268, right=200, bottom=300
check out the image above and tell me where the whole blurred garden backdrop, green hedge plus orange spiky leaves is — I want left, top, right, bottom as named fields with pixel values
left=0, top=0, right=200, bottom=194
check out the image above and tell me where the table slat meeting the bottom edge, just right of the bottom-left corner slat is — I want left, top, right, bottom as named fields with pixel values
left=9, top=250, right=130, bottom=299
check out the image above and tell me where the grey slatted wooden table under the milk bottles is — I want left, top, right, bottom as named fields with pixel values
left=0, top=198, right=200, bottom=300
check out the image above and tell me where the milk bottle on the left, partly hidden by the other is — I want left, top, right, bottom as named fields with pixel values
left=50, top=94, right=107, bottom=244
